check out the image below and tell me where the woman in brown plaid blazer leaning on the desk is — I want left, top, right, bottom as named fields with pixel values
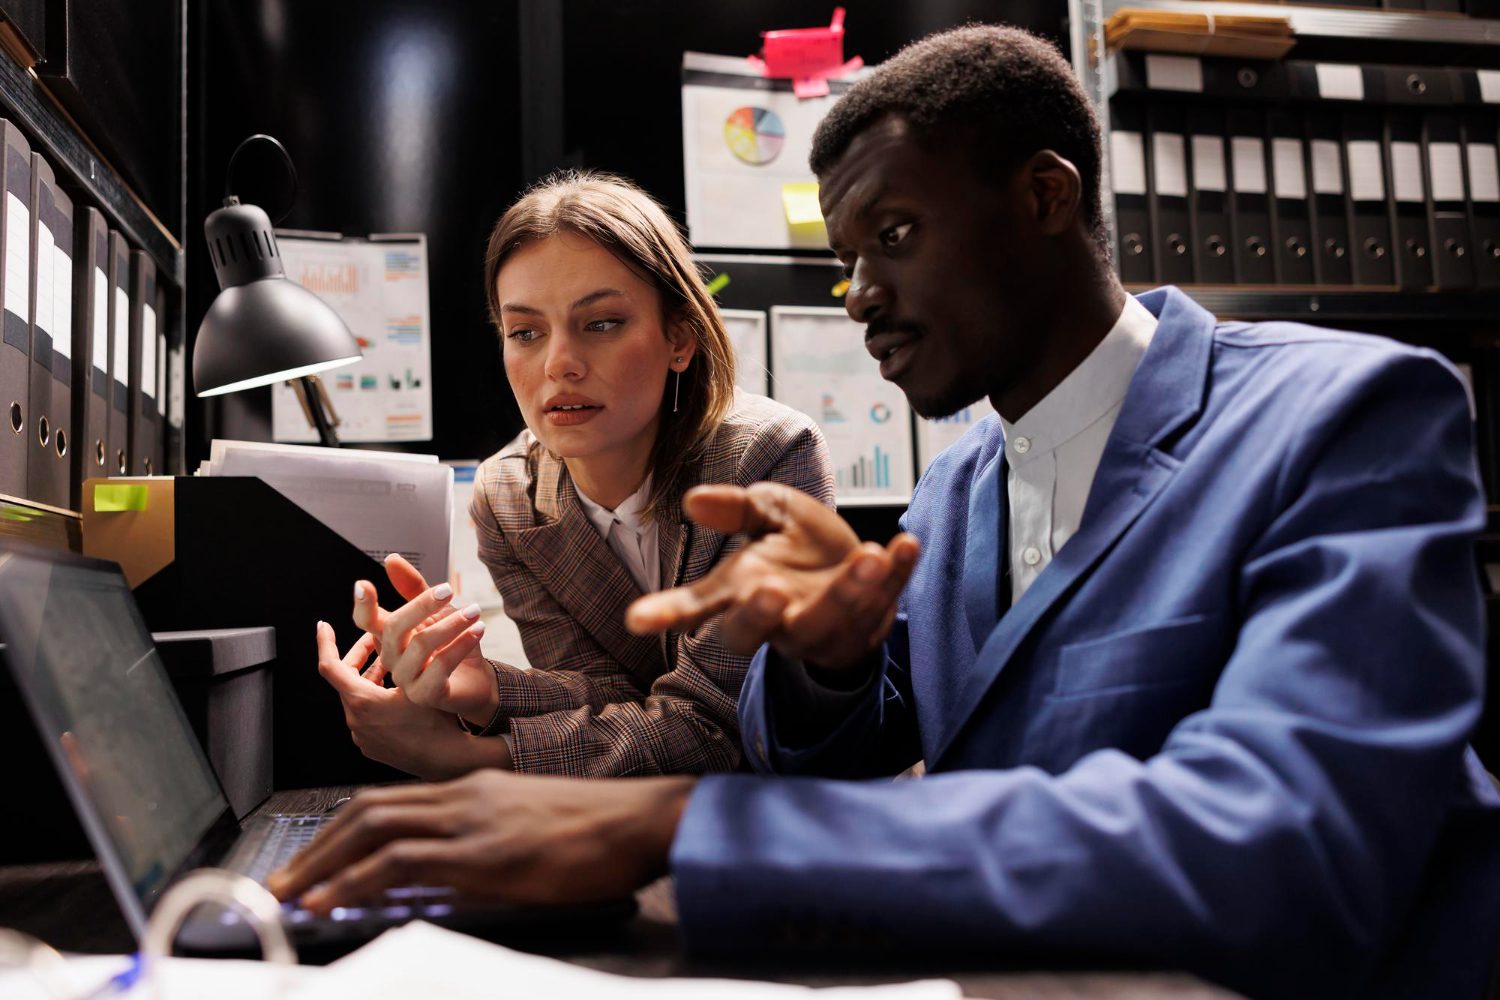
left=318, top=172, right=834, bottom=778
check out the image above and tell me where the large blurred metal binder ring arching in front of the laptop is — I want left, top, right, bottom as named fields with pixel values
left=141, top=868, right=297, bottom=997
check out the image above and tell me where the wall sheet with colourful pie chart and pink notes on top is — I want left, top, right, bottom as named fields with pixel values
left=683, top=52, right=864, bottom=250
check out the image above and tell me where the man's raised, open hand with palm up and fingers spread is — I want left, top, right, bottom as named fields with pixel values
left=626, top=483, right=920, bottom=670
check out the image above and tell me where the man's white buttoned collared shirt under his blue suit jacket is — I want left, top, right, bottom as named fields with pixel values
left=1001, top=295, right=1157, bottom=604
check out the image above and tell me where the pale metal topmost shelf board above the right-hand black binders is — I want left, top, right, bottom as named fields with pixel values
left=1103, top=0, right=1500, bottom=45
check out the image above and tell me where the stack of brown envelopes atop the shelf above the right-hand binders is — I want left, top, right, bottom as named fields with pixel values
left=1104, top=7, right=1296, bottom=58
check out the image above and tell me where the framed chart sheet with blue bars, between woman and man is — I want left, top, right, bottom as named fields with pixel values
left=771, top=306, right=914, bottom=505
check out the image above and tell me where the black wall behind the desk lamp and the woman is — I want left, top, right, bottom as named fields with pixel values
left=186, top=0, right=1065, bottom=466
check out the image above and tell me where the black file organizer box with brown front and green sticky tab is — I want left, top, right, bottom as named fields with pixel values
left=83, top=477, right=405, bottom=789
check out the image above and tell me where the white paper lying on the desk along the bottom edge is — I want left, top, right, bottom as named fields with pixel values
left=324, top=921, right=960, bottom=1000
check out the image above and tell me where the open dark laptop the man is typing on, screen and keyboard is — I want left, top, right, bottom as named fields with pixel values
left=0, top=541, right=635, bottom=955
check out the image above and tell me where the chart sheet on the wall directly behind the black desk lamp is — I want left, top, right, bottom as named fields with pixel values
left=272, top=231, right=432, bottom=442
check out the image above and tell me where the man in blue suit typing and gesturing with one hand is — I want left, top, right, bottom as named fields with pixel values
left=275, top=27, right=1500, bottom=997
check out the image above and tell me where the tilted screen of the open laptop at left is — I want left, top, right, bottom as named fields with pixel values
left=0, top=549, right=228, bottom=916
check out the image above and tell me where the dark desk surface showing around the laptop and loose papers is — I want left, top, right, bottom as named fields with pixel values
left=0, top=787, right=1238, bottom=1000
